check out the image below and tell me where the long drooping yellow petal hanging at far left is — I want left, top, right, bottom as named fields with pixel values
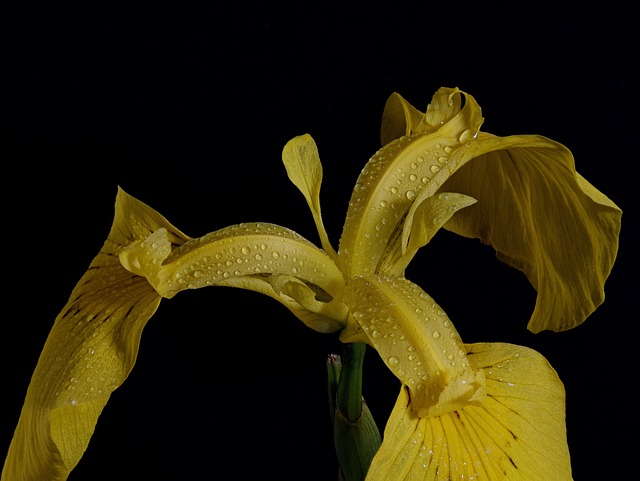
left=2, top=190, right=189, bottom=481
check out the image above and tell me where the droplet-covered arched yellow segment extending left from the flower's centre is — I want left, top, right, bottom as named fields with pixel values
left=120, top=223, right=344, bottom=304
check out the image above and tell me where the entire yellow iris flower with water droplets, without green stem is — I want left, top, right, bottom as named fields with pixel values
left=2, top=88, right=621, bottom=481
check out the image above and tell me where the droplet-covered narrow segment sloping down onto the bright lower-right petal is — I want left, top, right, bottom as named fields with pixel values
left=340, top=276, right=485, bottom=416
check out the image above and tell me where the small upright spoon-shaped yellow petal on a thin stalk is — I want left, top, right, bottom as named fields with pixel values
left=282, top=134, right=336, bottom=258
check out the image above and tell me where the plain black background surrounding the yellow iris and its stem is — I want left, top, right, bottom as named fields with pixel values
left=0, top=1, right=639, bottom=481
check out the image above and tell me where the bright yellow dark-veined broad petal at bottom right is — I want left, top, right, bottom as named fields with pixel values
left=366, top=343, right=571, bottom=481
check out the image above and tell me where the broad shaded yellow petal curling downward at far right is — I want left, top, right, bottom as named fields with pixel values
left=442, top=134, right=622, bottom=332
